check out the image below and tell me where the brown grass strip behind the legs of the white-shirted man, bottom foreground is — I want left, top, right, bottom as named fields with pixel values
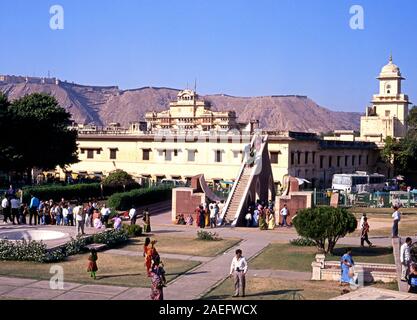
left=203, top=277, right=342, bottom=300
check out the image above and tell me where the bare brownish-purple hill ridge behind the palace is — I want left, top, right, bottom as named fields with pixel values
left=0, top=78, right=361, bottom=132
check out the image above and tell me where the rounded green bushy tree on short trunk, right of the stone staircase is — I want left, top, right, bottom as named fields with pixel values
left=293, top=207, right=357, bottom=253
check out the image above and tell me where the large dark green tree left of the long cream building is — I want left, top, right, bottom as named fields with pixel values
left=7, top=93, right=78, bottom=181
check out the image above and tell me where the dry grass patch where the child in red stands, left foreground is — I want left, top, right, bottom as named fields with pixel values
left=0, top=253, right=199, bottom=288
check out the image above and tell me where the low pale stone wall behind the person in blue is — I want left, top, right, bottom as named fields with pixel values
left=311, top=254, right=397, bottom=283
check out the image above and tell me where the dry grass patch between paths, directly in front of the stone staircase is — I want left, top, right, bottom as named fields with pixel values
left=123, top=235, right=241, bottom=257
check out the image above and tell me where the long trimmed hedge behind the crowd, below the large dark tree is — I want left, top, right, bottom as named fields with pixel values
left=23, top=183, right=140, bottom=203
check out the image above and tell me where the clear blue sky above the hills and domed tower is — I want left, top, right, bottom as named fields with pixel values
left=0, top=0, right=417, bottom=112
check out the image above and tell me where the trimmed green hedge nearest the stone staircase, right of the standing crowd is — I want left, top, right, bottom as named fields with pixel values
left=107, top=186, right=172, bottom=211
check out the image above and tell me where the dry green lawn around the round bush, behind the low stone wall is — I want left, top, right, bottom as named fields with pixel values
left=250, top=243, right=394, bottom=272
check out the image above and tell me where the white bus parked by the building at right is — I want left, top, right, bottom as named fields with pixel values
left=332, top=172, right=386, bottom=193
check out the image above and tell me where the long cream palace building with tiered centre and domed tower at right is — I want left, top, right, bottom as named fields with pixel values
left=63, top=58, right=409, bottom=188
